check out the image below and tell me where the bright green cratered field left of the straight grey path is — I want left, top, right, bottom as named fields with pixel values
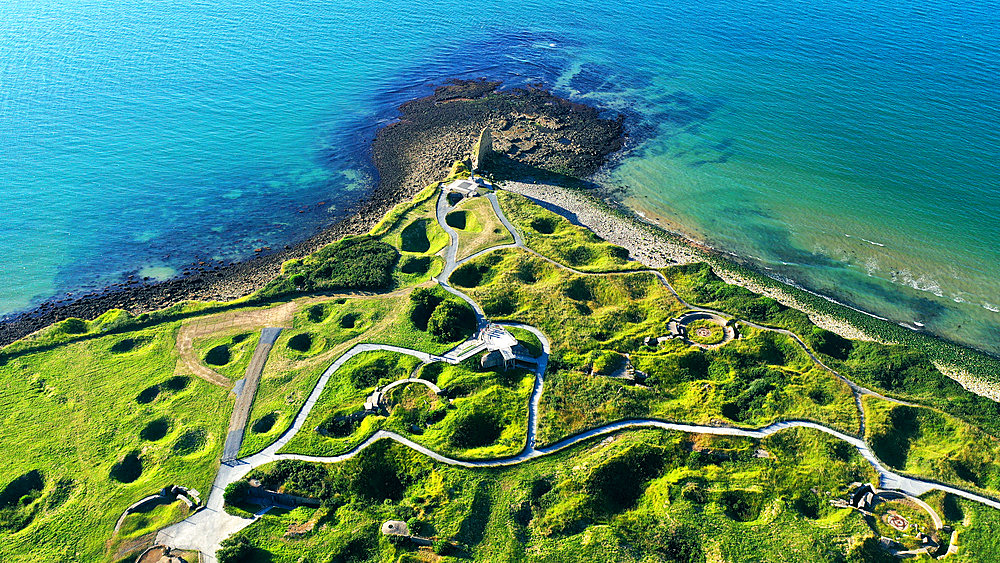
left=0, top=322, right=232, bottom=561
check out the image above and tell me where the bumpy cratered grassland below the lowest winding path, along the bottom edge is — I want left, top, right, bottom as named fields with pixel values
left=217, top=430, right=908, bottom=563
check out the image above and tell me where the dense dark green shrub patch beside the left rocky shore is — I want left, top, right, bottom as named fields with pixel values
left=260, top=236, right=399, bottom=297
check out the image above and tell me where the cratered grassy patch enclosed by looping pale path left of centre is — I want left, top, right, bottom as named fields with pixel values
left=283, top=352, right=534, bottom=459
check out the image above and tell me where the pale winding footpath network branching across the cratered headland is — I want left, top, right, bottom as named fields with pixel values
left=156, top=184, right=1000, bottom=562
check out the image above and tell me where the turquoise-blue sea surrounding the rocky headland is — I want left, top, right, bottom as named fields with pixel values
left=0, top=0, right=1000, bottom=352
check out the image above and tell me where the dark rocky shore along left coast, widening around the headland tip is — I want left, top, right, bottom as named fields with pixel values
left=0, top=79, right=625, bottom=346
